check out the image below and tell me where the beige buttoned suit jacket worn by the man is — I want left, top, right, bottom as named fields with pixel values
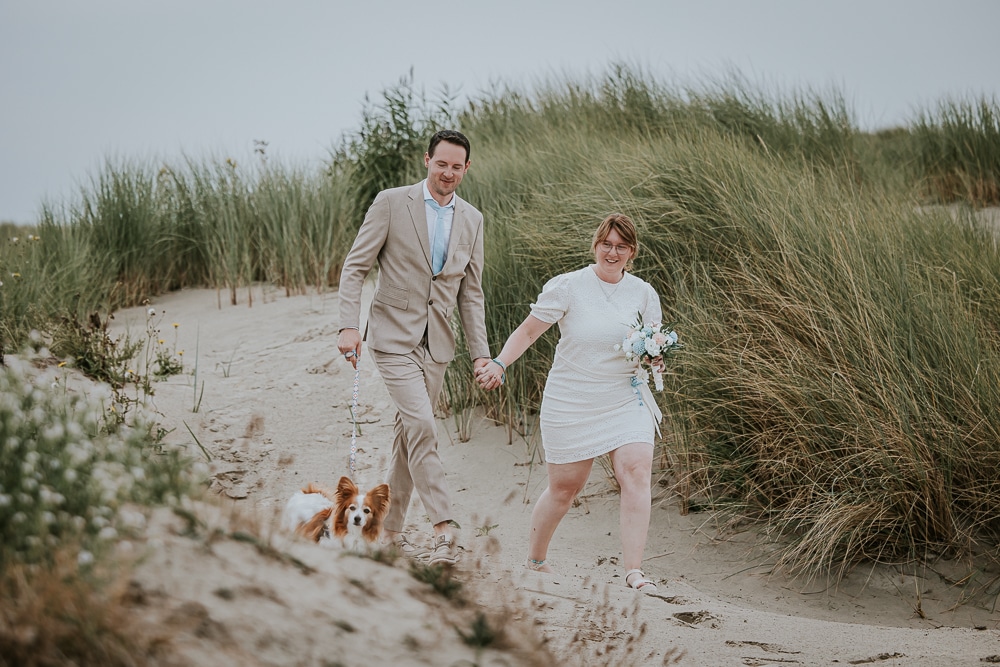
left=340, top=182, right=490, bottom=363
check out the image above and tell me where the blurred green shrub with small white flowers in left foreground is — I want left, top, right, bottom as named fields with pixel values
left=0, top=353, right=194, bottom=569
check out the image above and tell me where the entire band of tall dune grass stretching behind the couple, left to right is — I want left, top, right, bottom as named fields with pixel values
left=0, top=67, right=1000, bottom=594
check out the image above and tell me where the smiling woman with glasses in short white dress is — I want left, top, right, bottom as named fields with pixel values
left=477, top=214, right=662, bottom=593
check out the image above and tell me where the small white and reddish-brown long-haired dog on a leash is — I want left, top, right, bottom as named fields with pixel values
left=282, top=477, right=390, bottom=553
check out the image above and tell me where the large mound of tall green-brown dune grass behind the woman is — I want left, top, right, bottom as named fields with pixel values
left=463, top=73, right=1000, bottom=594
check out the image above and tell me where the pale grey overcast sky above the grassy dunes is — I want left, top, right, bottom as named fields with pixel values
left=0, top=0, right=1000, bottom=222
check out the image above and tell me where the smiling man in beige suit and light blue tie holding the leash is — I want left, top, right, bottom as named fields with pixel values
left=337, top=130, right=498, bottom=564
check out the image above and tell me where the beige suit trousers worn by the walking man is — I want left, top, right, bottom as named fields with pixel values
left=370, top=341, right=452, bottom=532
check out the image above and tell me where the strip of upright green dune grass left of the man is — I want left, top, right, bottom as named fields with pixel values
left=0, top=158, right=360, bottom=349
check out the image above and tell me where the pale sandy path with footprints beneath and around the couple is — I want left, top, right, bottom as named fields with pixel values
left=103, top=288, right=1000, bottom=665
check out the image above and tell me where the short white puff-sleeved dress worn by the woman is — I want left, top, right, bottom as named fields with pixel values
left=531, top=266, right=662, bottom=463
